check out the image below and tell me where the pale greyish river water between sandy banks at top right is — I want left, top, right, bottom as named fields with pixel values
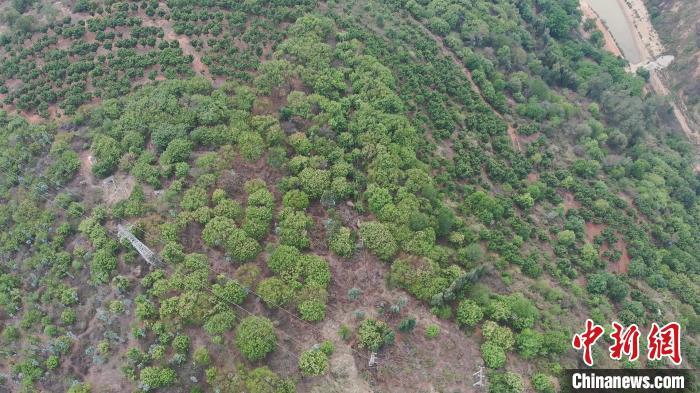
left=586, top=0, right=642, bottom=64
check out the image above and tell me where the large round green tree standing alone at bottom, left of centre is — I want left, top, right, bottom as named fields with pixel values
left=236, top=315, right=277, bottom=362
